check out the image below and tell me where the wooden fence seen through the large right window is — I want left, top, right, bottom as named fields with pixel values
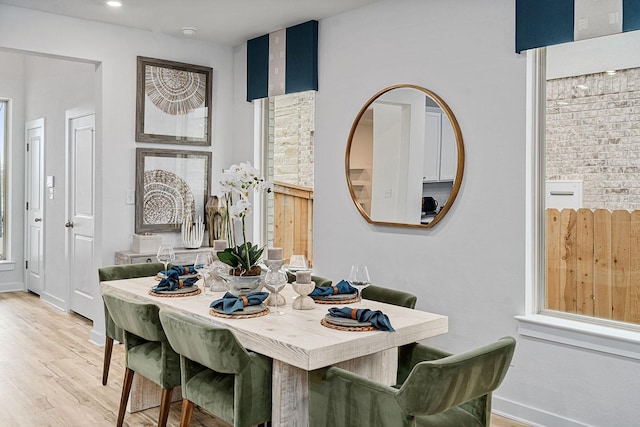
left=545, top=209, right=640, bottom=323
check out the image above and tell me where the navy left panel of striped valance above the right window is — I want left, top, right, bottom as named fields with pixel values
left=516, top=0, right=574, bottom=52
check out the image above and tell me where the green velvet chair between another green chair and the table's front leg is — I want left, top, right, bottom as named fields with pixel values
left=160, top=309, right=273, bottom=427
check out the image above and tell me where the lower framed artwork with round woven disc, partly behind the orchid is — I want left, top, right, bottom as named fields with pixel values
left=135, top=148, right=211, bottom=234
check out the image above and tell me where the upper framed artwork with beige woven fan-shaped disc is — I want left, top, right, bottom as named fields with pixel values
left=136, top=56, right=213, bottom=145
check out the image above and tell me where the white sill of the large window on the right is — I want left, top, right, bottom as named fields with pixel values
left=515, top=314, right=640, bottom=360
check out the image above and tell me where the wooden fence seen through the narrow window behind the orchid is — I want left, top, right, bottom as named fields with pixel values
left=273, top=182, right=313, bottom=265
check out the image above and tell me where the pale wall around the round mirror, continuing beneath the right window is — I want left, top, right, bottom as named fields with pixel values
left=248, top=0, right=640, bottom=426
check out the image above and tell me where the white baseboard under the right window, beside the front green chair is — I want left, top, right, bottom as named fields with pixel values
left=491, top=395, right=591, bottom=427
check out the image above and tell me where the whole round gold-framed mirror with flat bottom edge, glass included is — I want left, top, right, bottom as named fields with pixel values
left=345, top=84, right=464, bottom=228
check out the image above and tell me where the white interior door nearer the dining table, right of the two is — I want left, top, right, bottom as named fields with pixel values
left=65, top=111, right=97, bottom=320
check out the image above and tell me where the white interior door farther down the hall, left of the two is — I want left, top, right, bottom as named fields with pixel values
left=24, top=118, right=44, bottom=294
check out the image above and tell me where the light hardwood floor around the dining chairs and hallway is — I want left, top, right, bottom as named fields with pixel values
left=0, top=292, right=526, bottom=427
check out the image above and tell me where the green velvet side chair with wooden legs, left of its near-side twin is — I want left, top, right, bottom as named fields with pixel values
left=102, top=289, right=180, bottom=427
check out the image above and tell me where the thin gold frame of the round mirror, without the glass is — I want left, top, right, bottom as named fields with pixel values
left=345, top=84, right=464, bottom=228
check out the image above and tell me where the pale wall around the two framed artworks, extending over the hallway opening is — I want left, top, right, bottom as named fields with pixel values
left=0, top=5, right=234, bottom=340
